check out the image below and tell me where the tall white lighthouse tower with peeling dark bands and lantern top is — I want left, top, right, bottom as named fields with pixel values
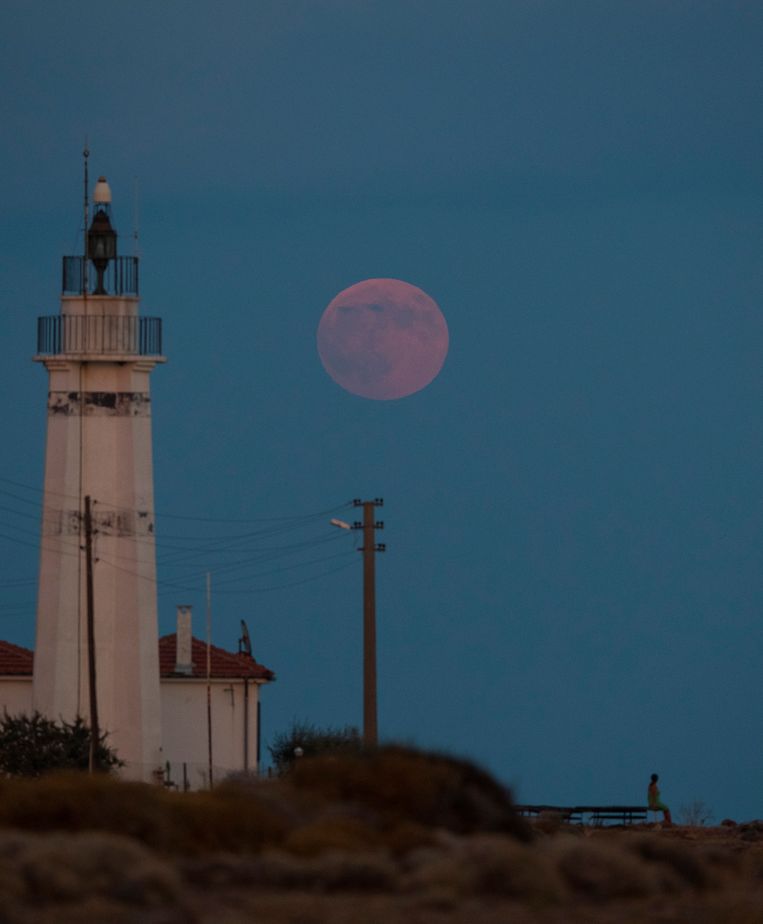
left=32, top=168, right=164, bottom=779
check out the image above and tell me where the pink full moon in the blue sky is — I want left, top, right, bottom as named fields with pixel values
left=317, top=279, right=448, bottom=401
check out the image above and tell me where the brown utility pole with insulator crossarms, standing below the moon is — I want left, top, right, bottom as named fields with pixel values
left=352, top=497, right=386, bottom=747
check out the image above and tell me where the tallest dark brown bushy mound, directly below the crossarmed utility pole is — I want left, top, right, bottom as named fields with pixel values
left=288, top=747, right=532, bottom=840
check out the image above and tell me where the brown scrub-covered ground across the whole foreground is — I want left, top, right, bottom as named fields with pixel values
left=0, top=753, right=763, bottom=924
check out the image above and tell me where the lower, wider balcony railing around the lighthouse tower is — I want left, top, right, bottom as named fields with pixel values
left=37, top=314, right=162, bottom=356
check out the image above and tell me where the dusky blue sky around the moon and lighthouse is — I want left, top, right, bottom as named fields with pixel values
left=0, top=0, right=763, bottom=821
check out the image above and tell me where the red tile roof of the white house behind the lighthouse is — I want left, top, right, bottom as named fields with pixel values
left=0, top=632, right=275, bottom=681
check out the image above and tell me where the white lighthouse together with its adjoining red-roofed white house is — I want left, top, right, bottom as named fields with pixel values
left=5, top=164, right=273, bottom=788
